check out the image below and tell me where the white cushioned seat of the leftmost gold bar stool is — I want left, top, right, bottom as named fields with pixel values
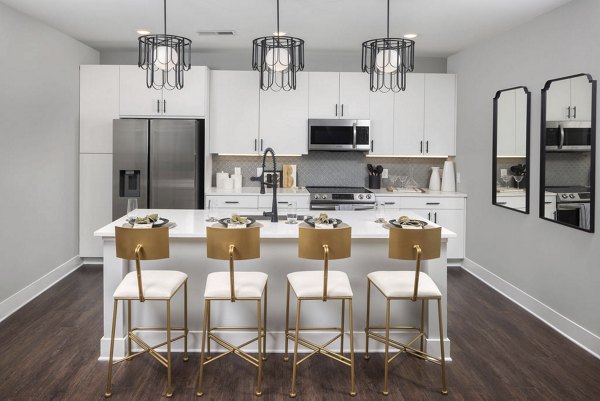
left=113, top=270, right=187, bottom=299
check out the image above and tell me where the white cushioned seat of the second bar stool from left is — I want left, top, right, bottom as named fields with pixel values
left=204, top=272, right=269, bottom=298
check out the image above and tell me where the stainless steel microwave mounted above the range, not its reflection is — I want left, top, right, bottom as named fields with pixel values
left=308, top=119, right=371, bottom=152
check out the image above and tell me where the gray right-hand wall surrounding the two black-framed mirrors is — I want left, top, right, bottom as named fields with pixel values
left=448, top=0, right=600, bottom=335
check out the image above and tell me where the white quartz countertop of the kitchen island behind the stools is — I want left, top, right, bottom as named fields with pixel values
left=94, top=209, right=456, bottom=239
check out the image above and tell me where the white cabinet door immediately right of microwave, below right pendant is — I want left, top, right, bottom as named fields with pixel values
left=369, top=91, right=394, bottom=155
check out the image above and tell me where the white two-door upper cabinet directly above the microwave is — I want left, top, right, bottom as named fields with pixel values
left=308, top=72, right=370, bottom=120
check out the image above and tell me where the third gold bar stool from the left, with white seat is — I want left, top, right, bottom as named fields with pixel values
left=284, top=224, right=356, bottom=398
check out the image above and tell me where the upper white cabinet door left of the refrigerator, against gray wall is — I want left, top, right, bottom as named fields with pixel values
left=79, top=65, right=119, bottom=153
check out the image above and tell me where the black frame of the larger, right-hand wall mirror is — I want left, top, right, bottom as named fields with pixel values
left=539, top=73, right=597, bottom=233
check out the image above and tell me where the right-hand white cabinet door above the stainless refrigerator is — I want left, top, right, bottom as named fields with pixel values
left=163, top=66, right=207, bottom=117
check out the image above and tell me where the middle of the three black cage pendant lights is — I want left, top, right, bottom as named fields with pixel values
left=252, top=0, right=304, bottom=91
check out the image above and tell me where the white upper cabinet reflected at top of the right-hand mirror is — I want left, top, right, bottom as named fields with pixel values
left=546, top=76, right=592, bottom=121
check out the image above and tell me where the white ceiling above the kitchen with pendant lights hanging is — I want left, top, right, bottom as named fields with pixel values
left=0, top=0, right=571, bottom=57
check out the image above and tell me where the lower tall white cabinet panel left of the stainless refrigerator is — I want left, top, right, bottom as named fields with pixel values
left=79, top=153, right=113, bottom=257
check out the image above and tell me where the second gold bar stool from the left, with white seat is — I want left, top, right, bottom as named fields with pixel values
left=196, top=226, right=268, bottom=397
